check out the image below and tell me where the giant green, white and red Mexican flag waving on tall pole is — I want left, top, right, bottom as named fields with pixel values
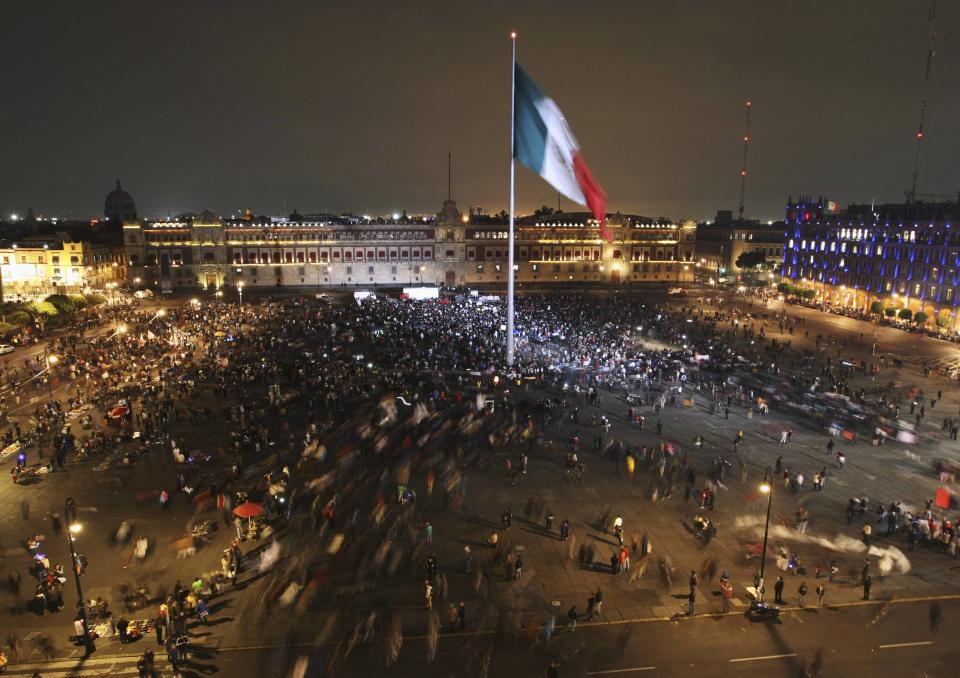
left=513, top=64, right=613, bottom=242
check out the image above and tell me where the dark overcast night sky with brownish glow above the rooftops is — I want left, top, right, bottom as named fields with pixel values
left=0, top=0, right=960, bottom=219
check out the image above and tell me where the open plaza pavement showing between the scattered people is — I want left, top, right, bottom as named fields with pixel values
left=0, top=294, right=960, bottom=676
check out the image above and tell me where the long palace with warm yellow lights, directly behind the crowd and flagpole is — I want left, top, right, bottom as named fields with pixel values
left=123, top=200, right=696, bottom=289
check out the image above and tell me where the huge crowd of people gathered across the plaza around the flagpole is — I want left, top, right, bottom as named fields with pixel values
left=0, top=294, right=955, bottom=675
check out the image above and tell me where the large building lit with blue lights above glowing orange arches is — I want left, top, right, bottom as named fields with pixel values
left=781, top=196, right=960, bottom=328
